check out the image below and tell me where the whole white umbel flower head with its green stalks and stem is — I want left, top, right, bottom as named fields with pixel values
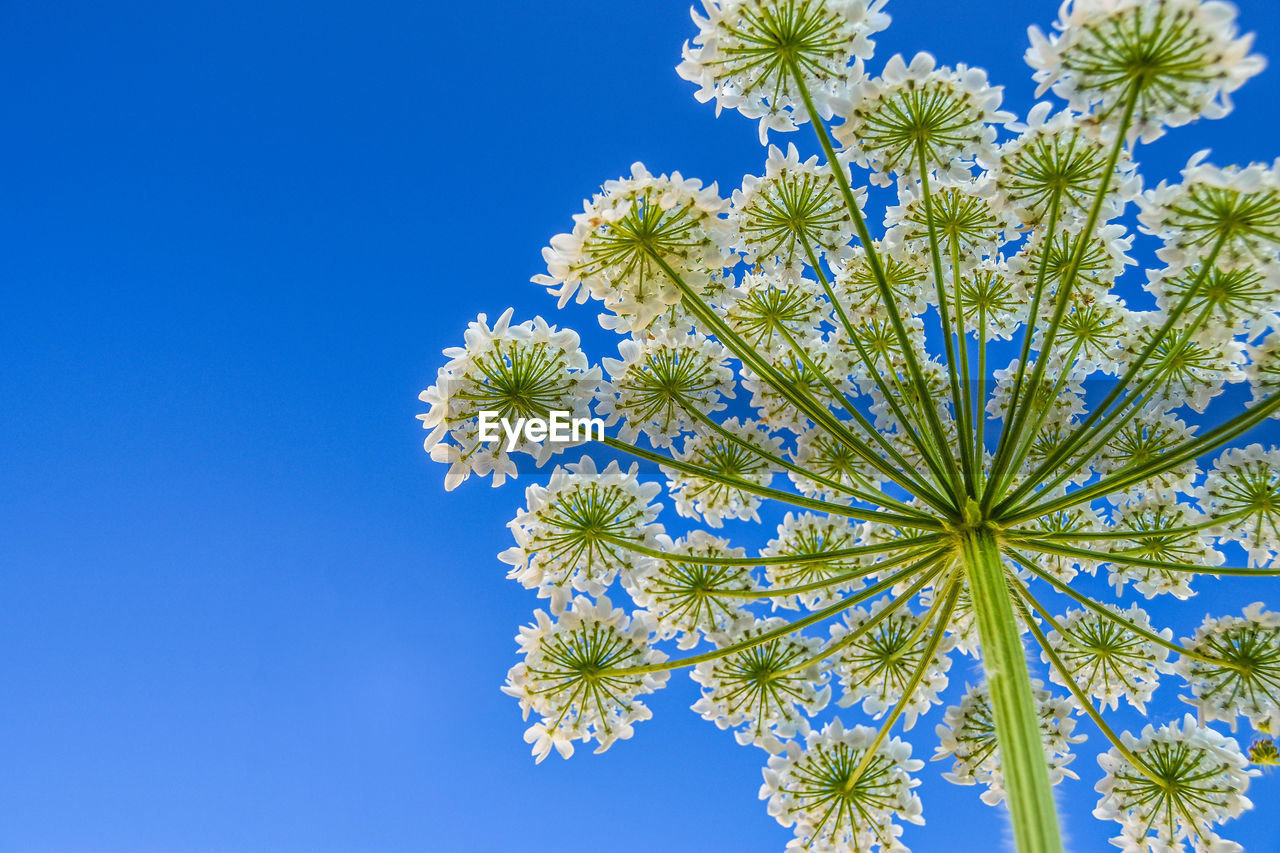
left=422, top=0, right=1280, bottom=853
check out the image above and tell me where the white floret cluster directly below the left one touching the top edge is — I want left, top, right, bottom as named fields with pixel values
left=730, top=145, right=867, bottom=270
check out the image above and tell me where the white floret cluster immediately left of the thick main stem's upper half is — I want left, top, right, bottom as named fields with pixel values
left=831, top=598, right=954, bottom=729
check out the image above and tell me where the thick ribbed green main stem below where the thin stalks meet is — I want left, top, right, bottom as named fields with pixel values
left=960, top=525, right=1062, bottom=853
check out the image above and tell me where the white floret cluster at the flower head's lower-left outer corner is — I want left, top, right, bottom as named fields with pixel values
left=502, top=596, right=669, bottom=762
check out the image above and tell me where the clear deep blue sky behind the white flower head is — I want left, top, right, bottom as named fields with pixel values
left=0, top=0, right=1280, bottom=853
